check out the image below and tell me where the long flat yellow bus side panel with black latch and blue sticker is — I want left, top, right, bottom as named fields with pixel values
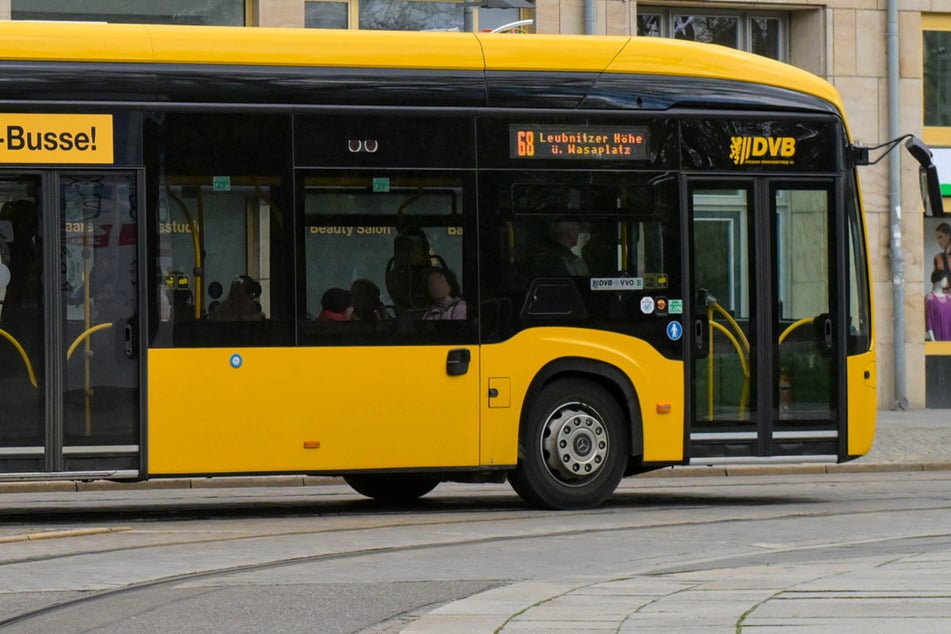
left=148, top=346, right=479, bottom=475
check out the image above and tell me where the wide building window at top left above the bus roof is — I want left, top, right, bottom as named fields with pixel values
left=10, top=0, right=246, bottom=26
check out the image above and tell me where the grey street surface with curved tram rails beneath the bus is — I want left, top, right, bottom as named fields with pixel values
left=0, top=471, right=951, bottom=634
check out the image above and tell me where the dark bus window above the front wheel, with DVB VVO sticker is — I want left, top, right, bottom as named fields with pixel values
left=481, top=173, right=683, bottom=358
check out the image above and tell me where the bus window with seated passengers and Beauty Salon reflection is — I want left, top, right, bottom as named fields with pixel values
left=301, top=174, right=474, bottom=345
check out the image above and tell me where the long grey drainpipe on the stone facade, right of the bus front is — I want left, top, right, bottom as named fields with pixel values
left=885, top=0, right=908, bottom=410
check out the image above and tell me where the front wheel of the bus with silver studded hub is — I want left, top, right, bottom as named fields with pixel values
left=509, top=379, right=630, bottom=509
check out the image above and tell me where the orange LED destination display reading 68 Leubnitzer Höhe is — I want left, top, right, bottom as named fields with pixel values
left=509, top=124, right=648, bottom=160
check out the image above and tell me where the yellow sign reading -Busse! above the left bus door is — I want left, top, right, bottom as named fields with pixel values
left=0, top=113, right=113, bottom=165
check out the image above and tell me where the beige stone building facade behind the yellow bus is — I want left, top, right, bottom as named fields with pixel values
left=0, top=0, right=951, bottom=408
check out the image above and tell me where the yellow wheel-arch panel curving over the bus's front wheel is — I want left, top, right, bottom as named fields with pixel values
left=481, top=328, right=686, bottom=466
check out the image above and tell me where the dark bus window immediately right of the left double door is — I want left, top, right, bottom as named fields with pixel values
left=146, top=113, right=291, bottom=347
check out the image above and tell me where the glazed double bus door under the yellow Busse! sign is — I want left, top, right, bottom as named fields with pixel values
left=0, top=171, right=141, bottom=477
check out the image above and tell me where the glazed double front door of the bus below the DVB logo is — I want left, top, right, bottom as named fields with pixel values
left=687, top=178, right=844, bottom=464
